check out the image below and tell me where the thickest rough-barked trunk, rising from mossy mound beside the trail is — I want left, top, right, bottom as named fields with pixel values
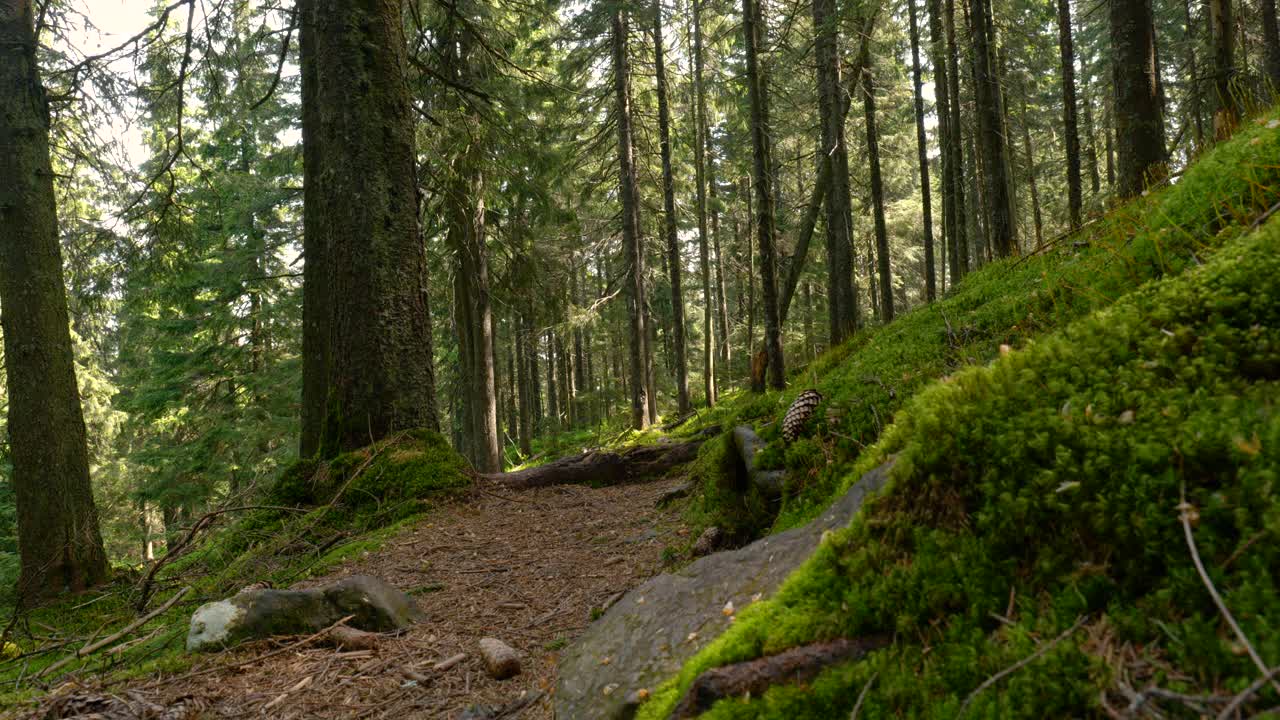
left=298, top=0, right=439, bottom=456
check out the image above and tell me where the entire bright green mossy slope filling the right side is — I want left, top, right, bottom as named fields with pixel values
left=641, top=110, right=1280, bottom=719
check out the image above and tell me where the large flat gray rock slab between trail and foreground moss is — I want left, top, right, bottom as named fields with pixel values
left=554, top=462, right=892, bottom=720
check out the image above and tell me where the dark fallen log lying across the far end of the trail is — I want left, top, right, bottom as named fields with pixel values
left=480, top=438, right=704, bottom=489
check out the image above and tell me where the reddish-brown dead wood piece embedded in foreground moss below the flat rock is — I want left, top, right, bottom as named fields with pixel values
left=669, top=635, right=890, bottom=720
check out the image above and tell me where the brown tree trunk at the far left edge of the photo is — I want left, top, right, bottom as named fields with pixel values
left=0, top=0, right=108, bottom=606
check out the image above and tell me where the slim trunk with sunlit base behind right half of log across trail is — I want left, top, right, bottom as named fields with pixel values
left=613, top=10, right=650, bottom=430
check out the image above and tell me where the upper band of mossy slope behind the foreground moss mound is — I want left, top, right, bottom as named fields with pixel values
left=686, top=110, right=1280, bottom=532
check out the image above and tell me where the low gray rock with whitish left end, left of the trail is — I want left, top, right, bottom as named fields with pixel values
left=187, top=575, right=422, bottom=651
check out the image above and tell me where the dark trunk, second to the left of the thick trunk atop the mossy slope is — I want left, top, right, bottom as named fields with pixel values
left=969, top=0, right=1018, bottom=258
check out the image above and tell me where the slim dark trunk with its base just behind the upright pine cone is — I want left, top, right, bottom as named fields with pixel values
left=742, top=0, right=786, bottom=389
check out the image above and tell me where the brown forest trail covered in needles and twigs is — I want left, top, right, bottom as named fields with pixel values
left=36, top=478, right=687, bottom=719
